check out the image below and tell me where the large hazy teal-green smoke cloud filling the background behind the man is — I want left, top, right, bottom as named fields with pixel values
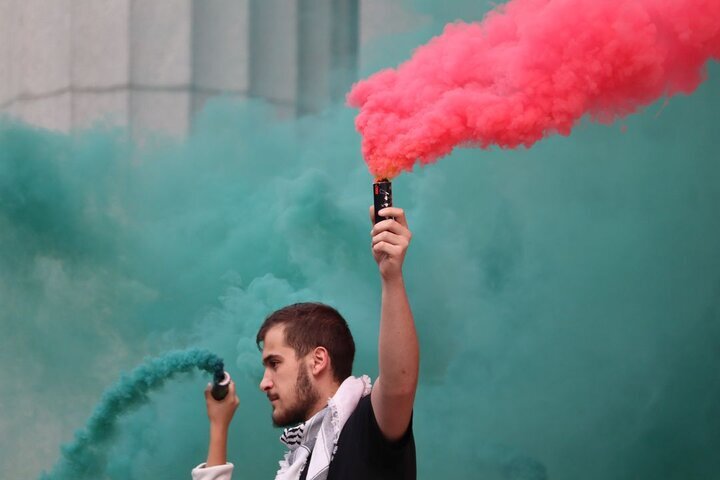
left=0, top=18, right=720, bottom=480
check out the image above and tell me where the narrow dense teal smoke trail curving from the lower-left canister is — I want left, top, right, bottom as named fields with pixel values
left=41, top=349, right=223, bottom=480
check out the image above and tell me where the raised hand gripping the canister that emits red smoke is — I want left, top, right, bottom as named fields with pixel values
left=370, top=206, right=412, bottom=280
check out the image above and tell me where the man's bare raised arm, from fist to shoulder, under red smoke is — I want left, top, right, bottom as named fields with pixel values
left=370, top=207, right=420, bottom=440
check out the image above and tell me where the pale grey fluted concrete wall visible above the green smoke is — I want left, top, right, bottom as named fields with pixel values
left=0, top=0, right=428, bottom=135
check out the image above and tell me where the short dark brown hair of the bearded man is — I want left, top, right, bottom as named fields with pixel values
left=255, top=303, right=355, bottom=382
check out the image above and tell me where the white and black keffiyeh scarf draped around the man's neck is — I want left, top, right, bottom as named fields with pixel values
left=275, top=375, right=372, bottom=480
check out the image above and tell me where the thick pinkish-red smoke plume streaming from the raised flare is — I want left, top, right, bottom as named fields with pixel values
left=348, top=0, right=720, bottom=178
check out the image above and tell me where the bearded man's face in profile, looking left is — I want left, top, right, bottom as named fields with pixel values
left=260, top=325, right=319, bottom=427
